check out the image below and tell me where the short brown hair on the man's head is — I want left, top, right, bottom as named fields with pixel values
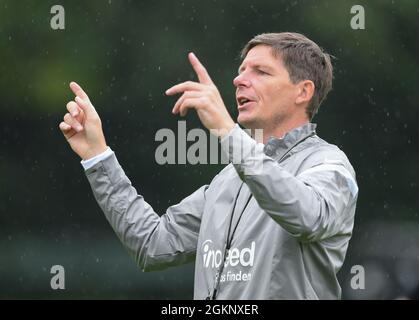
left=241, top=32, right=333, bottom=120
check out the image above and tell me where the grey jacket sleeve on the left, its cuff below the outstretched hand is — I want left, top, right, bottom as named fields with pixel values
left=86, top=154, right=207, bottom=271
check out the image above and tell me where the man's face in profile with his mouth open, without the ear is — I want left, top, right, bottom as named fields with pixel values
left=233, top=45, right=298, bottom=130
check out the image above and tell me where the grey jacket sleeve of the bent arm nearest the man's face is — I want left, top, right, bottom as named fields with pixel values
left=221, top=126, right=358, bottom=242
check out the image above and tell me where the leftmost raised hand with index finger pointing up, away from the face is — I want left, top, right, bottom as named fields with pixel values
left=59, top=82, right=107, bottom=160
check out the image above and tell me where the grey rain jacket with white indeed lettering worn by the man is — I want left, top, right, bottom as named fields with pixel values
left=86, top=123, right=358, bottom=299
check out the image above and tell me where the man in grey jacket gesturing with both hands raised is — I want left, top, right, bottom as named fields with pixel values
left=60, top=33, right=358, bottom=299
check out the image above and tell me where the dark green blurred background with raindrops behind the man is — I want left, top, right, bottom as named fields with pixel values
left=0, top=0, right=419, bottom=299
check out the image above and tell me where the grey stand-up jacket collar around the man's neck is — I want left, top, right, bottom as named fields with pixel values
left=263, top=122, right=317, bottom=158
